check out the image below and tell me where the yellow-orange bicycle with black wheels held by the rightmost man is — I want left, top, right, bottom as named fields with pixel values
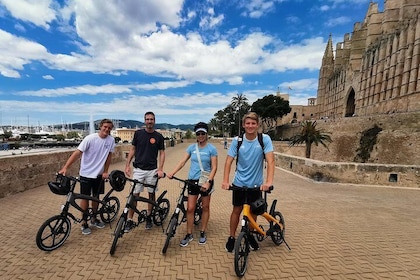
left=229, top=186, right=291, bottom=277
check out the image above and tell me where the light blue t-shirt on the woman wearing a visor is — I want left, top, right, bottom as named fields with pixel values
left=186, top=144, right=217, bottom=180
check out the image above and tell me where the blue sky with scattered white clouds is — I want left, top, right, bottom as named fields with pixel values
left=0, top=0, right=383, bottom=126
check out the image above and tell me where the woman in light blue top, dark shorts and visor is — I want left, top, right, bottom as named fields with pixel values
left=167, top=122, right=217, bottom=247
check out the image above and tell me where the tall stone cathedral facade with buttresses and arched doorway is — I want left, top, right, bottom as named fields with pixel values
left=315, top=0, right=420, bottom=119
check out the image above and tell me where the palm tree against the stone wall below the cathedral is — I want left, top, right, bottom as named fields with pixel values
left=289, top=121, right=332, bottom=158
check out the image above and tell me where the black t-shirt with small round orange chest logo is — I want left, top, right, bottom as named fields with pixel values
left=131, top=129, right=165, bottom=170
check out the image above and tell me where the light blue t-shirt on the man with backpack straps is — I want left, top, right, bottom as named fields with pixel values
left=228, top=134, right=273, bottom=188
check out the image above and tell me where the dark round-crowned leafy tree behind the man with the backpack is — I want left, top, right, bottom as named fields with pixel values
left=251, top=94, right=292, bottom=131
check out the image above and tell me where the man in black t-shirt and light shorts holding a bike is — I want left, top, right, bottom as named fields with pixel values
left=124, top=112, right=165, bottom=232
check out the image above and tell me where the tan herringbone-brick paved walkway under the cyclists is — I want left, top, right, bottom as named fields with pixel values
left=0, top=144, right=420, bottom=279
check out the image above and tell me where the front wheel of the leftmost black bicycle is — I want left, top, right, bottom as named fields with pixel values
left=36, top=215, right=71, bottom=251
